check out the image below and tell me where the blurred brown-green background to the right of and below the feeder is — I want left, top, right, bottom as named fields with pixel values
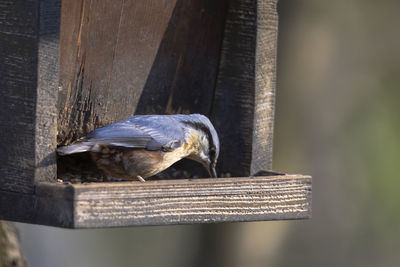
left=14, top=0, right=400, bottom=267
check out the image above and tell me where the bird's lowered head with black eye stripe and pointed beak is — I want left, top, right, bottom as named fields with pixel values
left=182, top=114, right=219, bottom=178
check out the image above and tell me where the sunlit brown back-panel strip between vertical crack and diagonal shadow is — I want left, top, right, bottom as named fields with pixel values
left=106, top=0, right=176, bottom=117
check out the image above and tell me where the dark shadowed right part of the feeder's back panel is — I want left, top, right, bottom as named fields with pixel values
left=136, top=0, right=228, bottom=116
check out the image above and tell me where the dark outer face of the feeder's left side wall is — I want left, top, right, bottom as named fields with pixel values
left=0, top=0, right=39, bottom=195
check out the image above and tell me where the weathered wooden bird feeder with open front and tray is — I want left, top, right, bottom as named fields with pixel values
left=0, top=0, right=311, bottom=228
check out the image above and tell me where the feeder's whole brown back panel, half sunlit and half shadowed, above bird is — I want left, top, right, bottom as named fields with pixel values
left=58, top=0, right=227, bottom=147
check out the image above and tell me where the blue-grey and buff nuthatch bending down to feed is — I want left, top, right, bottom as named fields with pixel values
left=57, top=114, right=220, bottom=182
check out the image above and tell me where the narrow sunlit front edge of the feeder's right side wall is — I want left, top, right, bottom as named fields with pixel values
left=250, top=0, right=278, bottom=173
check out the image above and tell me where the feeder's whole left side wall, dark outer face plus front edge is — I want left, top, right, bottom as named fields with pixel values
left=0, top=0, right=60, bottom=193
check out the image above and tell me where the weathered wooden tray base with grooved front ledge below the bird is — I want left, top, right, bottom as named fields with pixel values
left=0, top=175, right=311, bottom=228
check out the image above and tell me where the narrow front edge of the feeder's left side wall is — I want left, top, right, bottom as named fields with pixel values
left=35, top=0, right=61, bottom=182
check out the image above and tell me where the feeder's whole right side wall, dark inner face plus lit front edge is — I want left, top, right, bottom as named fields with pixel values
left=211, top=0, right=278, bottom=176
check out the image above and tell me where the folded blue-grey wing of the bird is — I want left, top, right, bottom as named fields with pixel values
left=82, top=115, right=184, bottom=151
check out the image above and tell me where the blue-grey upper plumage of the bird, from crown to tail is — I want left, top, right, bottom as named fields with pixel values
left=57, top=114, right=219, bottom=155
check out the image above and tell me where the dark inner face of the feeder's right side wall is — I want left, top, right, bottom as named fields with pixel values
left=212, top=0, right=258, bottom=176
